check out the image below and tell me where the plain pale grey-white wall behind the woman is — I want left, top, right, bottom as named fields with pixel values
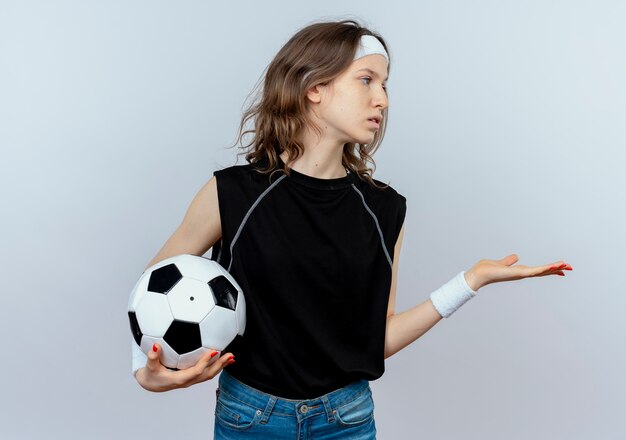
left=0, top=0, right=626, bottom=440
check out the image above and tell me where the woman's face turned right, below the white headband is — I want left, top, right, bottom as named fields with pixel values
left=309, top=54, right=389, bottom=145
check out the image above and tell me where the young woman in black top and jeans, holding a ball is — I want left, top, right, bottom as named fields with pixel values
left=133, top=20, right=572, bottom=439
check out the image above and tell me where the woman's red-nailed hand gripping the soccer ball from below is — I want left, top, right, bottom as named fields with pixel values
left=135, top=344, right=235, bottom=392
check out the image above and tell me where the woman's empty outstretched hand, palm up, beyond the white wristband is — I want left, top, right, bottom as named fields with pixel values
left=465, top=254, right=573, bottom=291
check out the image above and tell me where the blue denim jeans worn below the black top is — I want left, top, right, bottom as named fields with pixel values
left=214, top=370, right=376, bottom=440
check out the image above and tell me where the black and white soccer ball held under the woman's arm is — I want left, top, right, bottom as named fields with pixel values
left=128, top=254, right=246, bottom=369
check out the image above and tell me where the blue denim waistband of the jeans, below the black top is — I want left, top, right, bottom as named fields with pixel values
left=219, top=370, right=371, bottom=419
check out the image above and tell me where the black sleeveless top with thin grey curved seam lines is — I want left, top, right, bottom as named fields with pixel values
left=211, top=159, right=406, bottom=399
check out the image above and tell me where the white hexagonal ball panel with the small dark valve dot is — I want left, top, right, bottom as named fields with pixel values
left=167, top=278, right=215, bottom=322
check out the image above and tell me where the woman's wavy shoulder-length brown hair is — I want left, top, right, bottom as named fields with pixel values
left=229, top=20, right=389, bottom=188
